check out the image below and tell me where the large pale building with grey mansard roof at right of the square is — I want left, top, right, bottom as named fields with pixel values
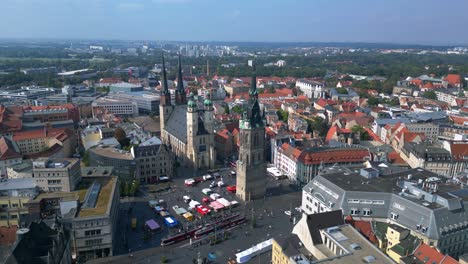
left=302, top=167, right=468, bottom=258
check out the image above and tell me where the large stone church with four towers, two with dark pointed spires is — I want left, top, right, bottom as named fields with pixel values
left=159, top=54, right=216, bottom=170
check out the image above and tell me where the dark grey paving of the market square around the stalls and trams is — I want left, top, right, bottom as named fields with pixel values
left=109, top=168, right=301, bottom=263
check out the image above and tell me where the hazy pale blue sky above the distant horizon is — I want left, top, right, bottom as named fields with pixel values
left=0, top=0, right=468, bottom=45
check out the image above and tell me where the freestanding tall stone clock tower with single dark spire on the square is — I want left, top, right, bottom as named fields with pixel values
left=236, top=64, right=266, bottom=201
